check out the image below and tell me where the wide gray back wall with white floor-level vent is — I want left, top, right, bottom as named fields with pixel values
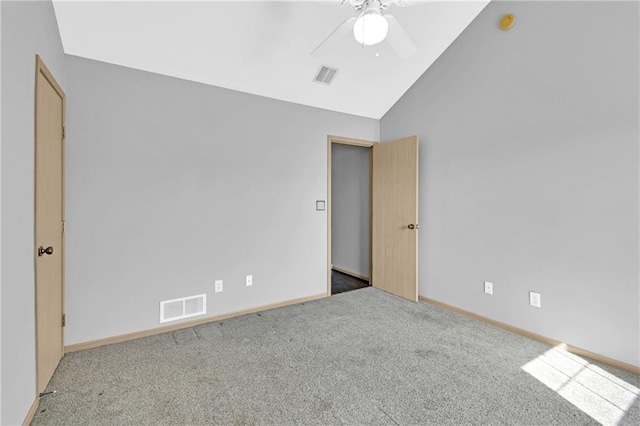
left=65, top=56, right=379, bottom=344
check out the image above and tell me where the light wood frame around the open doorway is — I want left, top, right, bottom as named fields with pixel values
left=327, top=135, right=378, bottom=296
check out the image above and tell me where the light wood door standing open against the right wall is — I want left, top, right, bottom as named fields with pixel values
left=371, top=136, right=418, bottom=301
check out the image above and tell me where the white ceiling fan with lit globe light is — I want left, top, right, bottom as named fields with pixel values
left=311, top=0, right=417, bottom=59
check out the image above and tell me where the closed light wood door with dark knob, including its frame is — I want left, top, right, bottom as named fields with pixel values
left=35, top=57, right=65, bottom=392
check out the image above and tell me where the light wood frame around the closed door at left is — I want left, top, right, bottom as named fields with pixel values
left=33, top=55, right=67, bottom=398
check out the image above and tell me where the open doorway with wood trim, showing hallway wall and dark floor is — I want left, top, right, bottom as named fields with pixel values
left=327, top=136, right=377, bottom=295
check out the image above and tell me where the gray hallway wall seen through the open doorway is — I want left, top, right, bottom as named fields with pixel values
left=331, top=143, right=371, bottom=277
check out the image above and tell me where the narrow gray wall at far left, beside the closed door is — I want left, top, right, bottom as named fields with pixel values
left=0, top=1, right=65, bottom=424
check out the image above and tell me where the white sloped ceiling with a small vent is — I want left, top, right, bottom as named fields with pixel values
left=53, top=0, right=489, bottom=118
